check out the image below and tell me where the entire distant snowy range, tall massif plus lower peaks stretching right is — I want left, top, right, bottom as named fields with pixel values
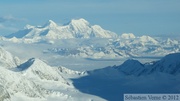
left=0, top=18, right=180, bottom=59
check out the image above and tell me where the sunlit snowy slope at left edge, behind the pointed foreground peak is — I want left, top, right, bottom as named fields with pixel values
left=0, top=47, right=20, bottom=68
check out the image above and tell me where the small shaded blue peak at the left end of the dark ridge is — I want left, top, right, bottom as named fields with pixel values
left=116, top=59, right=145, bottom=76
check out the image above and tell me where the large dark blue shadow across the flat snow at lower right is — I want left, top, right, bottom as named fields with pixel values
left=72, top=67, right=180, bottom=101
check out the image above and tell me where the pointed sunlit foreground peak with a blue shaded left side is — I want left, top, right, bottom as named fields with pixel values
left=17, top=58, right=67, bottom=84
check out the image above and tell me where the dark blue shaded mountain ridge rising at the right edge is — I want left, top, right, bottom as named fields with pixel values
left=114, top=53, right=180, bottom=76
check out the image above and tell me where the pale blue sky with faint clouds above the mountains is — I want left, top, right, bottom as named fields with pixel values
left=0, top=0, right=180, bottom=36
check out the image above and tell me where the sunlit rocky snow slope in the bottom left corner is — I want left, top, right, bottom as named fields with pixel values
left=0, top=67, right=44, bottom=98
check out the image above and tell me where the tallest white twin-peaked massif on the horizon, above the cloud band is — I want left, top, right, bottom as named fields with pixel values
left=6, top=18, right=117, bottom=40
